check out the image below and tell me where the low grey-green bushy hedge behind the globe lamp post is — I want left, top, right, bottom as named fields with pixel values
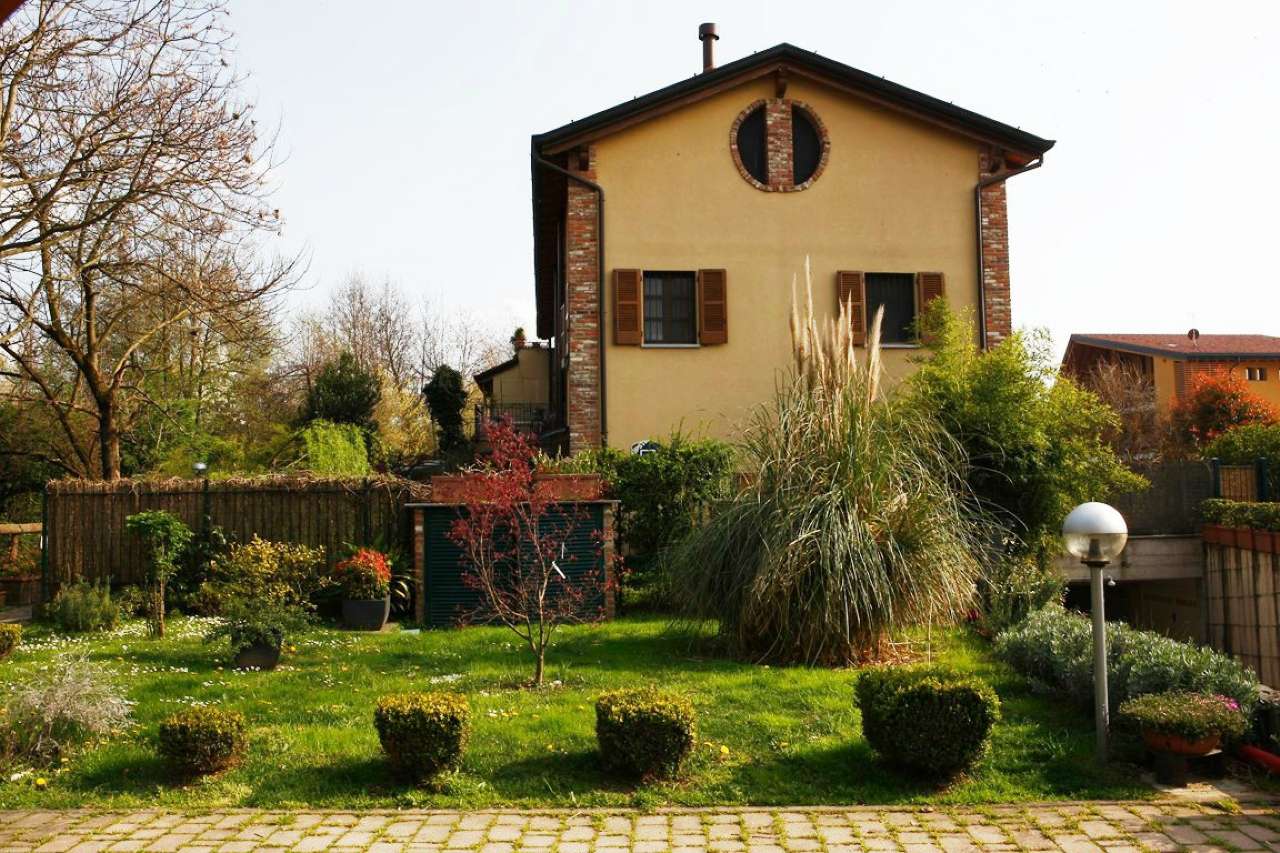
left=996, top=607, right=1258, bottom=712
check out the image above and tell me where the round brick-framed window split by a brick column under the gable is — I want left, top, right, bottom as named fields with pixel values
left=730, top=99, right=831, bottom=192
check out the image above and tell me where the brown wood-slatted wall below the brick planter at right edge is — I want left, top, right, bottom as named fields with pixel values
left=1203, top=525, right=1280, bottom=684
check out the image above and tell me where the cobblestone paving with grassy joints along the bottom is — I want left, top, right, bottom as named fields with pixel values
left=0, top=802, right=1280, bottom=853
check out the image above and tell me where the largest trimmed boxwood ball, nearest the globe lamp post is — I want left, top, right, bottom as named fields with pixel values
left=856, top=666, right=1000, bottom=779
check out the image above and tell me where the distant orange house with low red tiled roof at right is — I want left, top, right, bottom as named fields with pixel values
left=1062, top=330, right=1280, bottom=412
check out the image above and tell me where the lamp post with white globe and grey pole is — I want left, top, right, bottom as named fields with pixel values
left=1062, top=501, right=1129, bottom=763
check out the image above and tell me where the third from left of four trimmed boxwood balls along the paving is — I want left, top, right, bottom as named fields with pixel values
left=595, top=688, right=698, bottom=780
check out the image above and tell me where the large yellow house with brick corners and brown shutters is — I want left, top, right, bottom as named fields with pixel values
left=509, top=24, right=1053, bottom=452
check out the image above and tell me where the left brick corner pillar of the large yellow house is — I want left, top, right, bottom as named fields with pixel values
left=564, top=146, right=600, bottom=453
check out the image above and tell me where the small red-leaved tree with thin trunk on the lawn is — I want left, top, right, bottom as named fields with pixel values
left=449, top=420, right=608, bottom=686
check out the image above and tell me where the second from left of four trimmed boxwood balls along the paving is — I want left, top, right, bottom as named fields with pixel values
left=374, top=693, right=471, bottom=783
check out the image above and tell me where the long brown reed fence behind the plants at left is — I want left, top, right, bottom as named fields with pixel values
left=46, top=476, right=430, bottom=584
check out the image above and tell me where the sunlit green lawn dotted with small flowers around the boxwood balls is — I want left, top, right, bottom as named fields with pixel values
left=0, top=617, right=1152, bottom=808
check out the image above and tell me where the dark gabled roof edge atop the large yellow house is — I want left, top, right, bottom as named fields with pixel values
left=532, top=42, right=1053, bottom=160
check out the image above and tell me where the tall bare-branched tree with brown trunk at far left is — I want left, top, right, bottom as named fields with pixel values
left=0, top=0, right=296, bottom=479
